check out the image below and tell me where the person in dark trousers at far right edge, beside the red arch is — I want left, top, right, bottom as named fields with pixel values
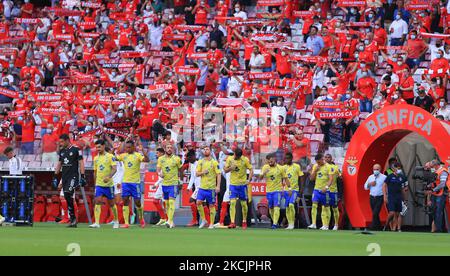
left=426, top=159, right=450, bottom=233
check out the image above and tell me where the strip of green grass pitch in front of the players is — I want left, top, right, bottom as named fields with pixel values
left=0, top=223, right=450, bottom=256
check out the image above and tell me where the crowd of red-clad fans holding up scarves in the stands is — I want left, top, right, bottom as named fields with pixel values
left=0, top=0, right=450, bottom=229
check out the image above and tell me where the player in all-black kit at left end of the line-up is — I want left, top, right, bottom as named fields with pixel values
left=53, top=134, right=86, bottom=228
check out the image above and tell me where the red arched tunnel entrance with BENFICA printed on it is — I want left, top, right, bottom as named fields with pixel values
left=342, top=105, right=450, bottom=227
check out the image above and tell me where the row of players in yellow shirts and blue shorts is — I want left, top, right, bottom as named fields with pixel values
left=85, top=135, right=339, bottom=230
